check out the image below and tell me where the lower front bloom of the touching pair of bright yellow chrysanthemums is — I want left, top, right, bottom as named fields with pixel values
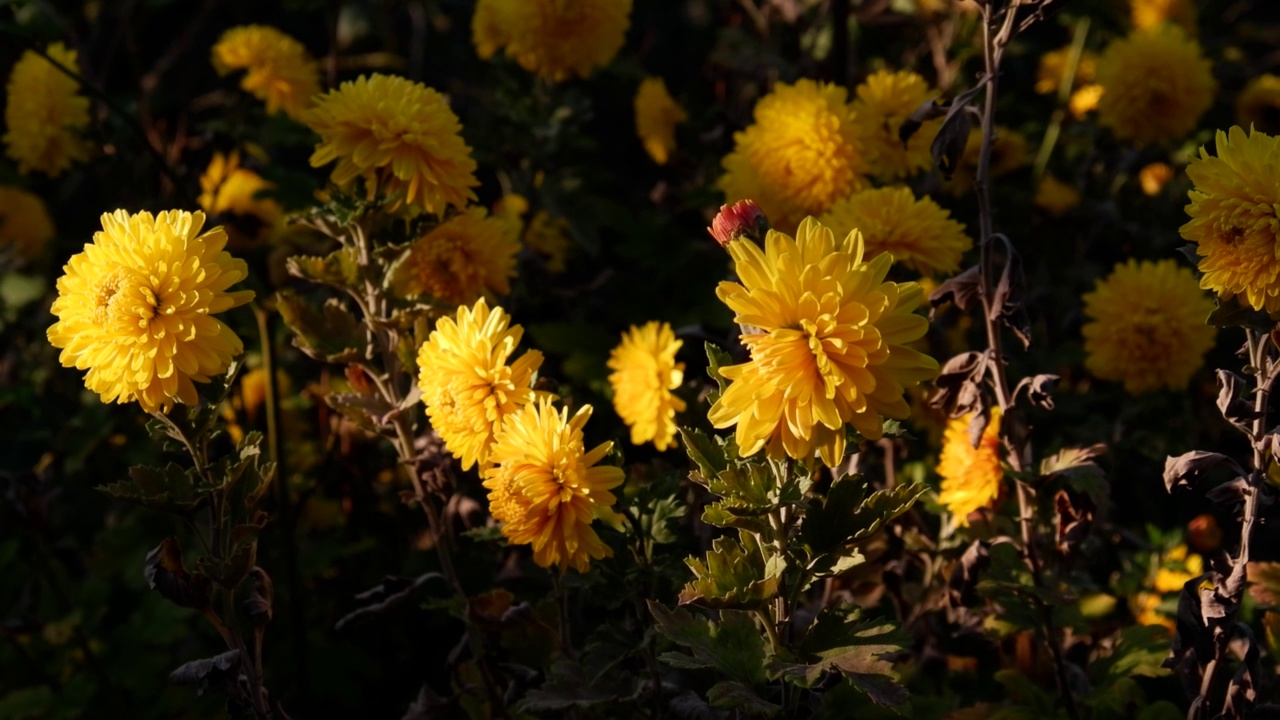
left=484, top=397, right=623, bottom=573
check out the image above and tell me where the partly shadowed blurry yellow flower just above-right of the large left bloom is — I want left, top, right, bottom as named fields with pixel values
left=198, top=151, right=284, bottom=246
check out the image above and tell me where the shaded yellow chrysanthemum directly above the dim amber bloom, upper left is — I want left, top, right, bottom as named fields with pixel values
left=306, top=74, right=480, bottom=214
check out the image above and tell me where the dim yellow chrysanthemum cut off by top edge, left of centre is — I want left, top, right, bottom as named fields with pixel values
left=488, top=0, right=631, bottom=82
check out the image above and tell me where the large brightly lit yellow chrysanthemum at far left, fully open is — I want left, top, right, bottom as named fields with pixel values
left=49, top=210, right=253, bottom=413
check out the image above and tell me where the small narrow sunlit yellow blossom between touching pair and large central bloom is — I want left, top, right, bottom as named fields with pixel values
left=608, top=322, right=685, bottom=450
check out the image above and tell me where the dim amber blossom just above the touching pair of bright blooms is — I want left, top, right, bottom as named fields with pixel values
left=392, top=208, right=520, bottom=305
